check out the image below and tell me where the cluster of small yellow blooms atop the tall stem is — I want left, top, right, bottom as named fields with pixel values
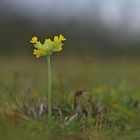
left=30, top=34, right=66, bottom=58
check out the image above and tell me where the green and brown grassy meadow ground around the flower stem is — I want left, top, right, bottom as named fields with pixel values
left=0, top=56, right=140, bottom=140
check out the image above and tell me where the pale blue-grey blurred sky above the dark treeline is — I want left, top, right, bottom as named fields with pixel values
left=0, top=0, right=140, bottom=32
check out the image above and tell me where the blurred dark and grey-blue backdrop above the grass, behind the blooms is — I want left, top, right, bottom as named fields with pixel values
left=0, top=0, right=140, bottom=58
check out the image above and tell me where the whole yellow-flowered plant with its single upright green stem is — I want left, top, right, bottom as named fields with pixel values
left=30, top=34, right=66, bottom=118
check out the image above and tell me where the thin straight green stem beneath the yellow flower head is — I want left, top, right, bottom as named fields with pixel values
left=47, top=56, right=52, bottom=118
